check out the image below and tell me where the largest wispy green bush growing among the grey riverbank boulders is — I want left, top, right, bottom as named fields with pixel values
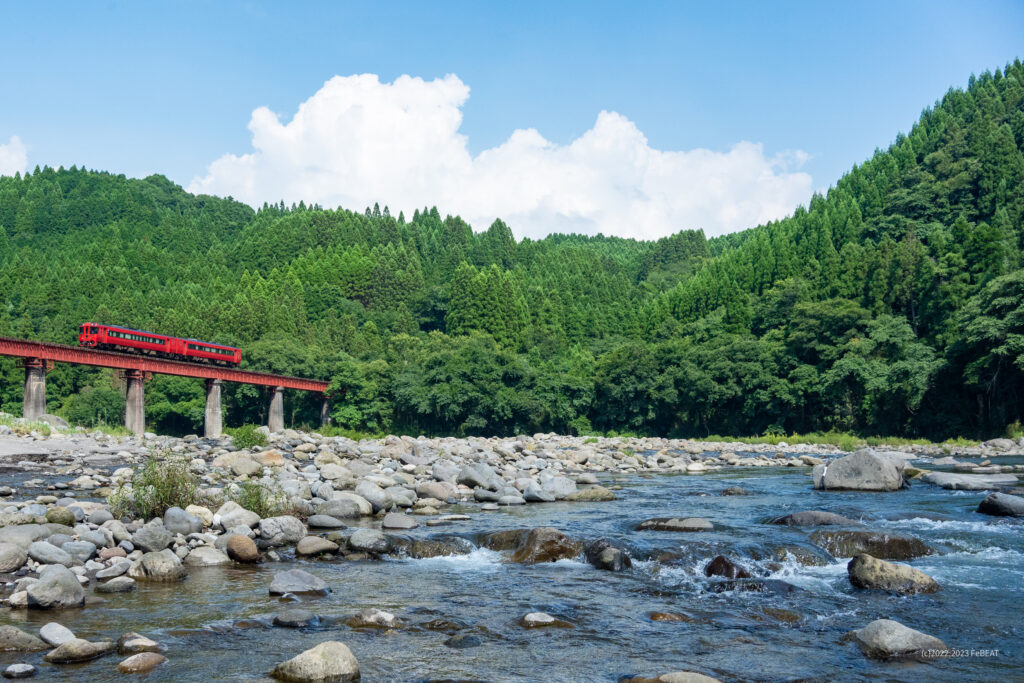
left=106, top=454, right=200, bottom=519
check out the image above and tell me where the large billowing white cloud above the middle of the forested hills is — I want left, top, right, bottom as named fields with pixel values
left=189, top=74, right=812, bottom=239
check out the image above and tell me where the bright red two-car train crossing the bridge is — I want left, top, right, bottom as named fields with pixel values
left=78, top=323, right=242, bottom=366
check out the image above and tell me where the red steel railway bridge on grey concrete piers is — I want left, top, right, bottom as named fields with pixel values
left=0, top=337, right=328, bottom=438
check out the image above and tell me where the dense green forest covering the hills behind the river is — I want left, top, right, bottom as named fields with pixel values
left=0, top=60, right=1024, bottom=439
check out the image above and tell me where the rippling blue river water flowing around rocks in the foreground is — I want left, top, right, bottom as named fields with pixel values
left=0, top=459, right=1024, bottom=681
